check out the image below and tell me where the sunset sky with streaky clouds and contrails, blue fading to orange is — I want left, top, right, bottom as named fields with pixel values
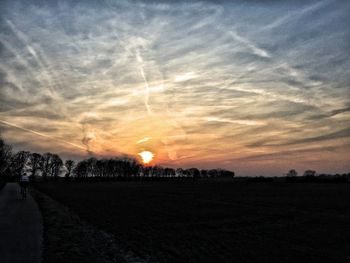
left=0, top=0, right=350, bottom=176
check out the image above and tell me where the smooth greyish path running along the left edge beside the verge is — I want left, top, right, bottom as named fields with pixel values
left=0, top=183, right=43, bottom=263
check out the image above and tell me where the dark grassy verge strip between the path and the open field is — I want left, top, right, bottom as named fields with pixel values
left=30, top=189, right=143, bottom=263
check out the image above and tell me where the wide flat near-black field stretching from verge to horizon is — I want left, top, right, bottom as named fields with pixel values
left=35, top=181, right=350, bottom=262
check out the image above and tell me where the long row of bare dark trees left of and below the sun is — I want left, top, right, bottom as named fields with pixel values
left=0, top=137, right=235, bottom=181
